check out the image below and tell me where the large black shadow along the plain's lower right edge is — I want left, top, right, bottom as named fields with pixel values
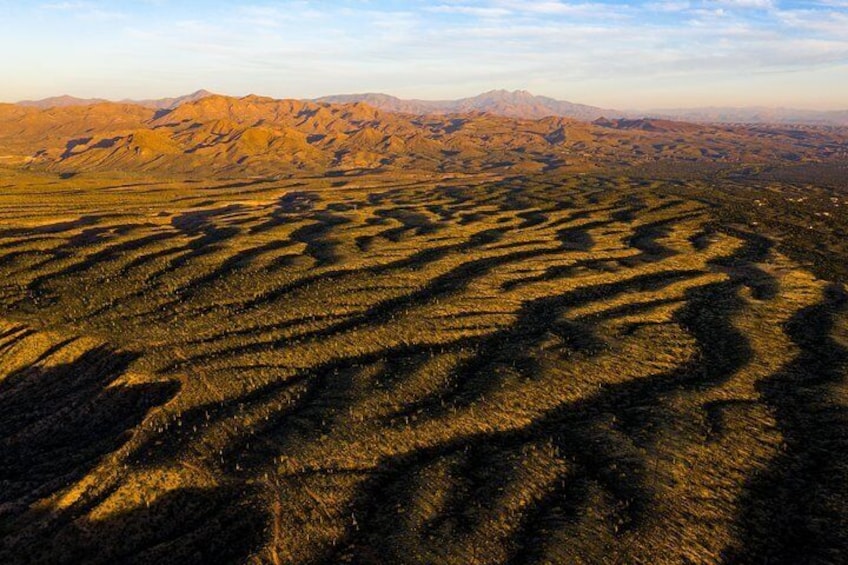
left=725, top=285, right=848, bottom=564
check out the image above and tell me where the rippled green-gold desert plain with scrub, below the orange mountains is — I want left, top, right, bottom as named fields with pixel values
left=0, top=149, right=848, bottom=564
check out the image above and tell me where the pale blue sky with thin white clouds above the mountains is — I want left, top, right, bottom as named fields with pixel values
left=0, top=0, right=848, bottom=110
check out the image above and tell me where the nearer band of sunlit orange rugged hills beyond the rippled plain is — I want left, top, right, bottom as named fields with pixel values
left=0, top=95, right=848, bottom=176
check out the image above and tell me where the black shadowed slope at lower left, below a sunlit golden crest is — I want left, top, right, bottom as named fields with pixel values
left=0, top=346, right=179, bottom=524
